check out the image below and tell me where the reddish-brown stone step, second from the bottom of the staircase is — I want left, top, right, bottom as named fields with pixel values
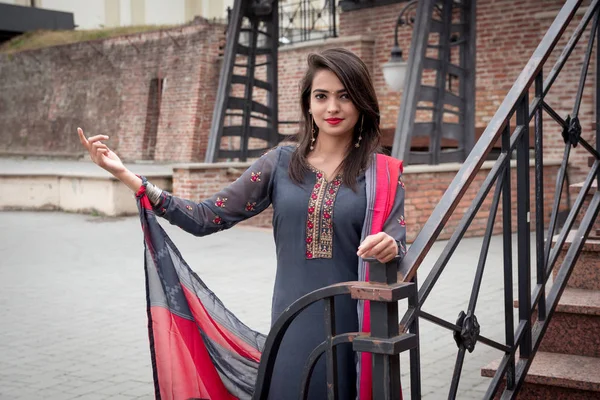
left=540, top=288, right=600, bottom=356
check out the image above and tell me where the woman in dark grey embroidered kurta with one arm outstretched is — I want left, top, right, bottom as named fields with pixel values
left=78, top=49, right=406, bottom=400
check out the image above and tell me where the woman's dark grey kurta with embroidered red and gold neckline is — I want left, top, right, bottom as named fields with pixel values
left=155, top=146, right=405, bottom=400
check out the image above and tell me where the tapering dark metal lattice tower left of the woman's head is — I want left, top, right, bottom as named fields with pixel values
left=205, top=0, right=282, bottom=163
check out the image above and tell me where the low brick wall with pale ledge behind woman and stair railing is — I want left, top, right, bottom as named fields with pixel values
left=173, top=162, right=565, bottom=242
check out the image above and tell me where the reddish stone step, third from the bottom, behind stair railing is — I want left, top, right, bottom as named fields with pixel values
left=552, top=230, right=600, bottom=290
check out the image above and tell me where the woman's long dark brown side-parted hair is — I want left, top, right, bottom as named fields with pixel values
left=289, top=48, right=381, bottom=188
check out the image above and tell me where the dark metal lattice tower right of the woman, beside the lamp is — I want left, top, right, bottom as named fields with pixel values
left=392, top=0, right=476, bottom=164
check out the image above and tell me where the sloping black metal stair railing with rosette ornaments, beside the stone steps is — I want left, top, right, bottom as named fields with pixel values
left=399, top=0, right=600, bottom=399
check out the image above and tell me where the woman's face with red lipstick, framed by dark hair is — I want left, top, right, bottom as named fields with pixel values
left=309, top=69, right=359, bottom=140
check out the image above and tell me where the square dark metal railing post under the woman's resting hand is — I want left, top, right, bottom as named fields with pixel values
left=352, top=260, right=418, bottom=400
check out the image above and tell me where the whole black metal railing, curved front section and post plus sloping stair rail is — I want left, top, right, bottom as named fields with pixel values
left=253, top=0, right=600, bottom=399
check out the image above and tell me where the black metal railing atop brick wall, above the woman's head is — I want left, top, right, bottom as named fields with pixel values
left=279, top=0, right=337, bottom=45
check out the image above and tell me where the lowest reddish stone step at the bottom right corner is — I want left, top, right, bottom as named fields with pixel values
left=481, top=351, right=600, bottom=400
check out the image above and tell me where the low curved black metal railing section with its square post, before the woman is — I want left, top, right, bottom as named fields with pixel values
left=252, top=259, right=420, bottom=400
